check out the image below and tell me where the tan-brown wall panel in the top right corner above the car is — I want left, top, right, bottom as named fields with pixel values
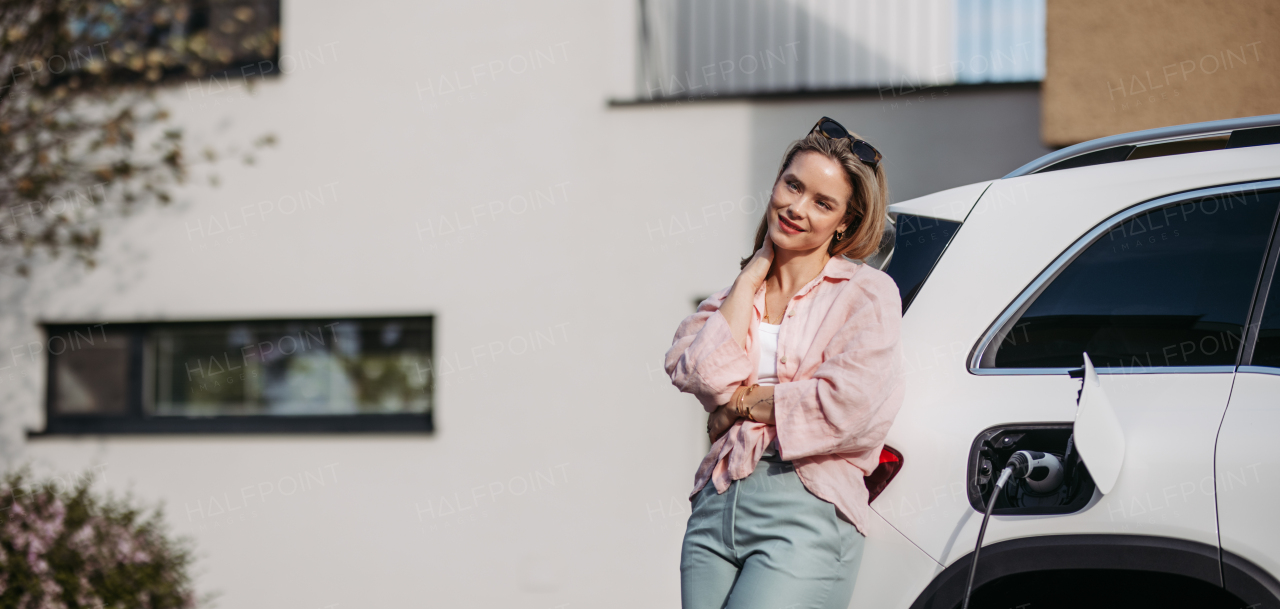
left=1041, top=0, right=1280, bottom=147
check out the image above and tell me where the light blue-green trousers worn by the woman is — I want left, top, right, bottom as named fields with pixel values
left=680, top=445, right=864, bottom=609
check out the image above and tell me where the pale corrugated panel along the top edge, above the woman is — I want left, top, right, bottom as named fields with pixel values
left=636, top=0, right=1044, bottom=100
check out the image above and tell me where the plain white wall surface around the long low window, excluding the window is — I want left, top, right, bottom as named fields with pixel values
left=0, top=0, right=1044, bottom=609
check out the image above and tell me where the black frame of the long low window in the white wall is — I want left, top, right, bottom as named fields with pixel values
left=27, top=315, right=438, bottom=438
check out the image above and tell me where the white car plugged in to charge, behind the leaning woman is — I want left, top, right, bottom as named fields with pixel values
left=851, top=115, right=1280, bottom=609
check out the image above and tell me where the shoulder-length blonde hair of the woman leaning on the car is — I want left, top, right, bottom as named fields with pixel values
left=740, top=132, right=888, bottom=269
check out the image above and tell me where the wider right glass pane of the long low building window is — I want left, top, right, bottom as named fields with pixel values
left=151, top=319, right=431, bottom=416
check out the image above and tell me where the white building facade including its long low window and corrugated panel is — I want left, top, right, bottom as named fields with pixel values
left=0, top=0, right=1047, bottom=609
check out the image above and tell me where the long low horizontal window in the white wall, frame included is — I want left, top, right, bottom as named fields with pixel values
left=46, top=317, right=433, bottom=434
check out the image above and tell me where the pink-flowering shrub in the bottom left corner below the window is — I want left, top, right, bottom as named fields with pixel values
left=0, top=470, right=196, bottom=609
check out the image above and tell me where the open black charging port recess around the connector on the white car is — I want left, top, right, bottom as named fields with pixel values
left=968, top=422, right=1096, bottom=516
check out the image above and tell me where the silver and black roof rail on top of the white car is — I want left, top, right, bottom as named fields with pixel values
left=1005, top=114, right=1280, bottom=178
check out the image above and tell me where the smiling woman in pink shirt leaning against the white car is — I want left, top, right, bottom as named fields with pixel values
left=666, top=116, right=904, bottom=609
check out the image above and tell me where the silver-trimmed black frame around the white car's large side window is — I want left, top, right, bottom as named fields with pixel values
left=966, top=179, right=1280, bottom=376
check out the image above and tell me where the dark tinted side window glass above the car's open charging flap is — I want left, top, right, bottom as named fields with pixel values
left=980, top=191, right=1280, bottom=371
